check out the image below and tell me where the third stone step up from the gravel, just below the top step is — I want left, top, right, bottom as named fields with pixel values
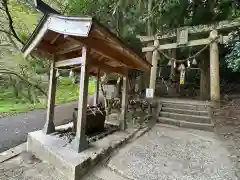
left=162, top=107, right=208, bottom=116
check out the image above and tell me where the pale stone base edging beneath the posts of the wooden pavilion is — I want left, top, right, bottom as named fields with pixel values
left=28, top=128, right=142, bottom=180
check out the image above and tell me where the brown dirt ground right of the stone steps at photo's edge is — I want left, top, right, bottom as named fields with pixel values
left=214, top=99, right=240, bottom=179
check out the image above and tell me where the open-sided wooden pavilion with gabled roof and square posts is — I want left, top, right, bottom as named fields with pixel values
left=22, top=14, right=151, bottom=152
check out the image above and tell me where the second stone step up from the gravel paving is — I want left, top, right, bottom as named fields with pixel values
left=160, top=112, right=211, bottom=124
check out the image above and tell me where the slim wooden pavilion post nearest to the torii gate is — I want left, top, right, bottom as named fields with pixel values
left=120, top=69, right=129, bottom=130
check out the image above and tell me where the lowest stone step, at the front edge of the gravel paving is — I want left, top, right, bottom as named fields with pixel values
left=158, top=117, right=214, bottom=132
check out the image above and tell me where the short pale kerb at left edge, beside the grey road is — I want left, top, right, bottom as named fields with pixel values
left=0, top=143, right=27, bottom=163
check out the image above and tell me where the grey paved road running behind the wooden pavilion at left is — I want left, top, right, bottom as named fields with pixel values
left=0, top=102, right=77, bottom=152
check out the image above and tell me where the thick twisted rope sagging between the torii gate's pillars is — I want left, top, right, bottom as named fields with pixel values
left=153, top=36, right=220, bottom=62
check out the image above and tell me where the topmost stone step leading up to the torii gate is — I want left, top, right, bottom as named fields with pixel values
left=162, top=102, right=208, bottom=111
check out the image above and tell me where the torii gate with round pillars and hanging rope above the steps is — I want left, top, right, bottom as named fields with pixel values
left=138, top=19, right=240, bottom=101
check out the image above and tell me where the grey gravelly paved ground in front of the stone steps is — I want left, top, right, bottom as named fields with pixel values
left=84, top=125, right=237, bottom=180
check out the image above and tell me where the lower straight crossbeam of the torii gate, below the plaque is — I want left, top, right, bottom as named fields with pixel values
left=142, top=38, right=215, bottom=52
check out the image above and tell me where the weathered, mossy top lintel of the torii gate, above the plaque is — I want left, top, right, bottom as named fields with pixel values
left=137, top=18, right=240, bottom=42
